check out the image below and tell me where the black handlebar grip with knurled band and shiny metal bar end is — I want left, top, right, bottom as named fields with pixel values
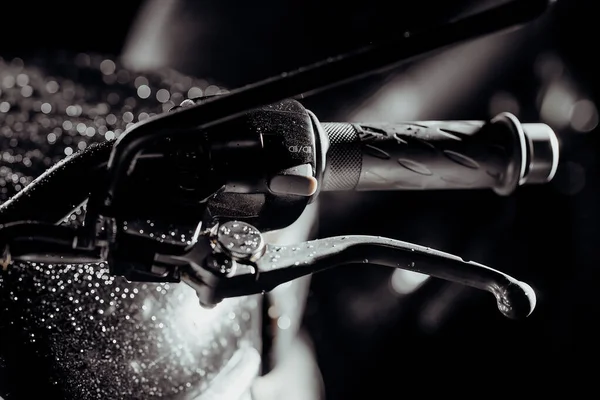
left=322, top=113, right=559, bottom=195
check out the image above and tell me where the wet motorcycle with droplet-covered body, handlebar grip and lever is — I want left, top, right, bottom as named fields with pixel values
left=0, top=1, right=559, bottom=399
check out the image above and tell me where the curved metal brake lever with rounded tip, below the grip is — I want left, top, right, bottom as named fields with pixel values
left=180, top=221, right=536, bottom=319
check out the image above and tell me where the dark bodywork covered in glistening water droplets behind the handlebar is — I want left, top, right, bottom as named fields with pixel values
left=0, top=54, right=259, bottom=400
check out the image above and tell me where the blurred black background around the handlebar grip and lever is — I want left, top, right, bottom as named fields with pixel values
left=0, top=0, right=600, bottom=400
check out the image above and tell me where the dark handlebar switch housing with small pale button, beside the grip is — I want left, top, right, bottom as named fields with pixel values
left=161, top=98, right=323, bottom=231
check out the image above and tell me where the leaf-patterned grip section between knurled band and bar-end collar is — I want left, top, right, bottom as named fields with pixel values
left=354, top=121, right=502, bottom=190
